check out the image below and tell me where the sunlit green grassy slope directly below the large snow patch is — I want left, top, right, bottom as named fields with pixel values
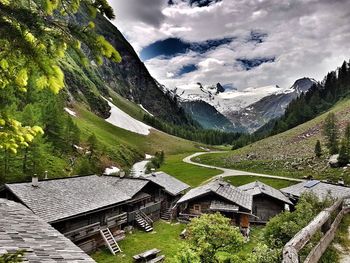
left=75, top=105, right=198, bottom=166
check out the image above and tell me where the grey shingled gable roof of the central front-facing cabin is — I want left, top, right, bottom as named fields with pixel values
left=177, top=179, right=253, bottom=211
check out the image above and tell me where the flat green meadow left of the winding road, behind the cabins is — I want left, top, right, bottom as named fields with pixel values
left=159, top=153, right=221, bottom=187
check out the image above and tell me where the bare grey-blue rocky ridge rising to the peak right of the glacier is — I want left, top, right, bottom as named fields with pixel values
left=226, top=78, right=317, bottom=132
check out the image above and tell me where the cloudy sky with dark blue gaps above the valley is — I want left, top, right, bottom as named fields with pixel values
left=109, top=0, right=350, bottom=90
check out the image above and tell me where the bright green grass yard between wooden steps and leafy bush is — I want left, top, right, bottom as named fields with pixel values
left=91, top=221, right=185, bottom=263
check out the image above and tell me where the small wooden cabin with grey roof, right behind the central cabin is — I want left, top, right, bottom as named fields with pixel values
left=238, top=181, right=293, bottom=223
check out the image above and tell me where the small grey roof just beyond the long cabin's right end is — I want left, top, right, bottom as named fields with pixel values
left=143, top=172, right=190, bottom=196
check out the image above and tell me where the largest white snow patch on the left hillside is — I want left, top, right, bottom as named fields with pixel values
left=105, top=99, right=152, bottom=135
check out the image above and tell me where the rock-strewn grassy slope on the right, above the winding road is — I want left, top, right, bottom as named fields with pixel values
left=196, top=99, right=350, bottom=183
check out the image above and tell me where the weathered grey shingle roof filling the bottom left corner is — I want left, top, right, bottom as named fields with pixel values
left=0, top=199, right=95, bottom=263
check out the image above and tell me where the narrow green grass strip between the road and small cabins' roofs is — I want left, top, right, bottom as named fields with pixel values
left=224, top=175, right=297, bottom=189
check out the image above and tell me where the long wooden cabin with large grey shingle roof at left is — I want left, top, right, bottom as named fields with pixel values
left=0, top=175, right=189, bottom=252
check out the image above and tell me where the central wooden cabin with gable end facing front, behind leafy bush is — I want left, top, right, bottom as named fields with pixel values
left=177, top=179, right=253, bottom=228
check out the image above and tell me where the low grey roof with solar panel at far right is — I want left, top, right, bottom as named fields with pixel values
left=281, top=180, right=350, bottom=198
